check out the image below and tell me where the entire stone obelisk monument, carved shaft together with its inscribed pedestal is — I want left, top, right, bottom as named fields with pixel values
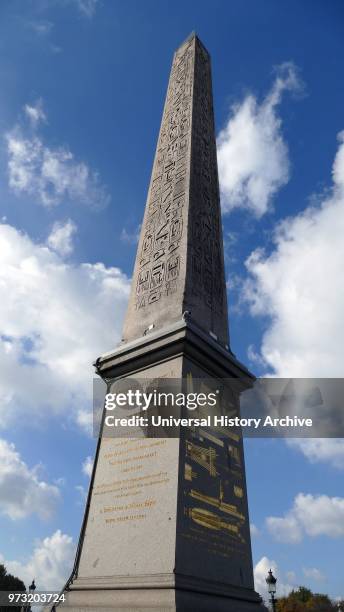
left=61, top=34, right=263, bottom=612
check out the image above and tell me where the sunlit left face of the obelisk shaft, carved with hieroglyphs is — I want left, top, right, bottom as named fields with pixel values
left=136, top=42, right=194, bottom=309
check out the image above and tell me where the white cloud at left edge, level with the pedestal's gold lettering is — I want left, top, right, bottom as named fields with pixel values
left=0, top=439, right=60, bottom=520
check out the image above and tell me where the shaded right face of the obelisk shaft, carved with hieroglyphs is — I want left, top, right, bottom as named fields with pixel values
left=190, top=41, right=226, bottom=315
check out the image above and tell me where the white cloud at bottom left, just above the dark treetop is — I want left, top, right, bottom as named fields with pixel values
left=0, top=530, right=75, bottom=591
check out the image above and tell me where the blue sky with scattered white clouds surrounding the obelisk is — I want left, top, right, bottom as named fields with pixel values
left=0, top=0, right=344, bottom=597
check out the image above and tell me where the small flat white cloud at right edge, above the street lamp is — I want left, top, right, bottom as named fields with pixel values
left=266, top=493, right=344, bottom=544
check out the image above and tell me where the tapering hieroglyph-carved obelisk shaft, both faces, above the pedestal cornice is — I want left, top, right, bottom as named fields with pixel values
left=123, top=36, right=228, bottom=344
